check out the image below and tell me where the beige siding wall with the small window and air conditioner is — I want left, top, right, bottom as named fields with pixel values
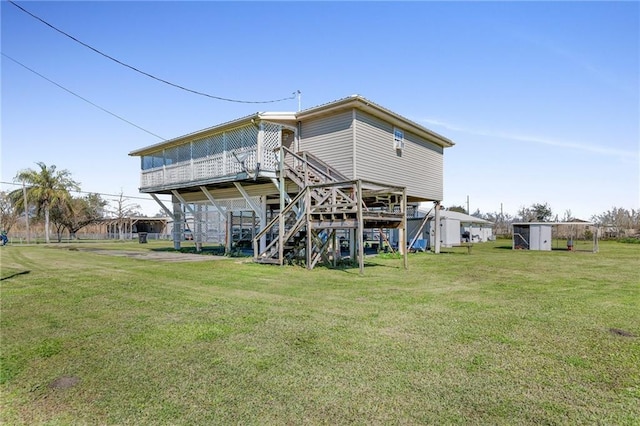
left=352, top=111, right=443, bottom=200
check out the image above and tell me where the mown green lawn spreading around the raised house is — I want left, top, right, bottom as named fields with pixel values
left=0, top=241, right=640, bottom=425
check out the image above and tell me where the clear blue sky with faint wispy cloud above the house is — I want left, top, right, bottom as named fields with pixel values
left=1, top=1, right=640, bottom=219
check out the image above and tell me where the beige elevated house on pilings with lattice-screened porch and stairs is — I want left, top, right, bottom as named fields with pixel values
left=129, top=95, right=453, bottom=271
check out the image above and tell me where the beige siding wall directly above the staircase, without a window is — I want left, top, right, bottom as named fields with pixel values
left=300, top=111, right=353, bottom=177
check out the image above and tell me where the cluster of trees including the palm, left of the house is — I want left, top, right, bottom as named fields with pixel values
left=0, top=162, right=140, bottom=243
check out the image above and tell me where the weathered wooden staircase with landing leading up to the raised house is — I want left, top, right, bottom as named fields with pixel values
left=254, top=147, right=404, bottom=269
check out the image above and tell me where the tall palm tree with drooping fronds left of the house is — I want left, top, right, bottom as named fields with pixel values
left=11, top=162, right=80, bottom=243
